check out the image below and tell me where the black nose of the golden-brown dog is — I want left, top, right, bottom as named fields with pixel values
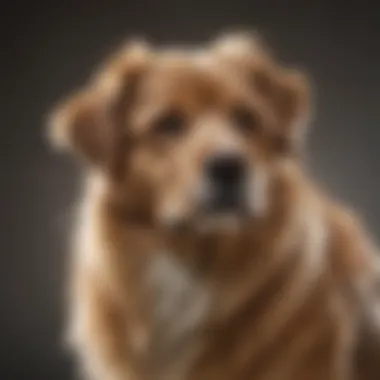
left=206, top=153, right=245, bottom=188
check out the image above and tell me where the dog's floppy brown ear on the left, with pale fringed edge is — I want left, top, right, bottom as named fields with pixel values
left=48, top=43, right=149, bottom=165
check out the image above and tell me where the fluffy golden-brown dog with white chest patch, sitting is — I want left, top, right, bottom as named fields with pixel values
left=49, top=34, right=380, bottom=380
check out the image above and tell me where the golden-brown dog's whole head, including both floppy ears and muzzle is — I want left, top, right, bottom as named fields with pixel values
left=49, top=34, right=308, bottom=232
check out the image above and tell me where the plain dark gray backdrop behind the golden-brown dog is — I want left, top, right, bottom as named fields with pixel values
left=0, top=0, right=380, bottom=380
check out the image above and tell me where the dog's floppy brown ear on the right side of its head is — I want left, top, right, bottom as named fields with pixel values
left=214, top=33, right=310, bottom=147
